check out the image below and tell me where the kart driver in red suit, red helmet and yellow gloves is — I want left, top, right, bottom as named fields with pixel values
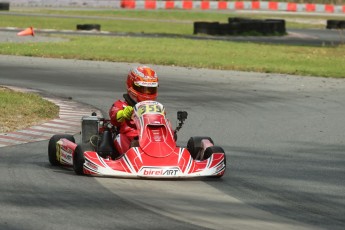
left=109, top=66, right=158, bottom=154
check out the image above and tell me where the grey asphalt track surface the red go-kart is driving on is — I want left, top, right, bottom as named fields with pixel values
left=0, top=56, right=345, bottom=230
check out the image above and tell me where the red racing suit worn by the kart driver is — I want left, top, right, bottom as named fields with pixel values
left=109, top=94, right=138, bottom=154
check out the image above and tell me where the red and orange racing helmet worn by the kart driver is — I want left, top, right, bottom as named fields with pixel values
left=127, top=66, right=158, bottom=102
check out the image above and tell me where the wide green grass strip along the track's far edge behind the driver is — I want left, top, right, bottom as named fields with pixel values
left=0, top=36, right=345, bottom=78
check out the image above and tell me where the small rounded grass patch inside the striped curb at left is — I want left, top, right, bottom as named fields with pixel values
left=0, top=87, right=59, bottom=133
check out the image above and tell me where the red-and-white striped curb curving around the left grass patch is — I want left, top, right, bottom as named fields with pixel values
left=0, top=86, right=102, bottom=148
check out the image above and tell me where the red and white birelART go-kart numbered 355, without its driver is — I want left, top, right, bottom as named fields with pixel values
left=48, top=101, right=226, bottom=178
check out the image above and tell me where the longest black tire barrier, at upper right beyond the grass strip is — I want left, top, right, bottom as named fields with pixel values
left=194, top=18, right=286, bottom=36
